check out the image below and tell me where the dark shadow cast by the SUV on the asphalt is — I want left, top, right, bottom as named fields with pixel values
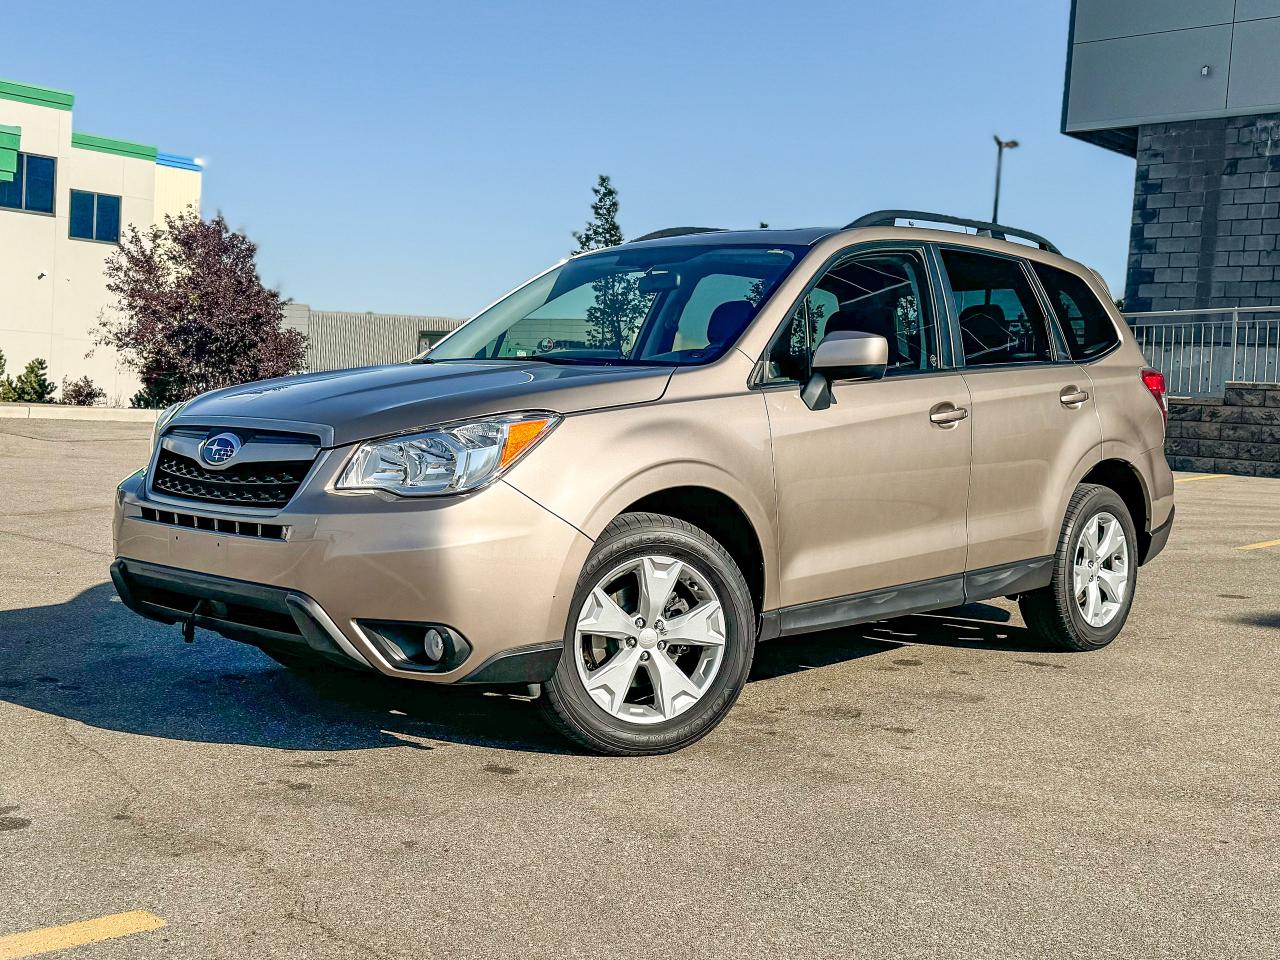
left=0, top=582, right=1044, bottom=754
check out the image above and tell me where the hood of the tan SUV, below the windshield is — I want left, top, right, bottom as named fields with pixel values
left=174, top=361, right=672, bottom=447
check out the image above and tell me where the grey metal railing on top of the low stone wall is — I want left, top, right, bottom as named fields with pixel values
left=1124, top=306, right=1280, bottom=397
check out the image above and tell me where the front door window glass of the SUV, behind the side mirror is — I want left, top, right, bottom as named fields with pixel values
left=769, top=252, right=940, bottom=380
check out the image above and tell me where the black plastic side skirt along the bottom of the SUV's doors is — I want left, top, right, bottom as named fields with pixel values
left=760, top=557, right=1053, bottom=640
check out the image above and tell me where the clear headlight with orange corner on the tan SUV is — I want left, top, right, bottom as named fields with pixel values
left=337, top=412, right=561, bottom=497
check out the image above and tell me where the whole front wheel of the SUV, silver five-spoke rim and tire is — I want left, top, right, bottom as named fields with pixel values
left=543, top=513, right=756, bottom=754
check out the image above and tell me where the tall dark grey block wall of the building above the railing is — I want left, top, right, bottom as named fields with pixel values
left=1125, top=114, right=1280, bottom=312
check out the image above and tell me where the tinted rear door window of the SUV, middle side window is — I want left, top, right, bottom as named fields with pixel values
left=942, top=248, right=1053, bottom=366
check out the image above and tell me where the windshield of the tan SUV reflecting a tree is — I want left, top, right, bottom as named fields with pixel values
left=419, top=244, right=805, bottom=365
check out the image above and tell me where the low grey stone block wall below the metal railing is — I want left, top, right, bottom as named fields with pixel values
left=1165, top=383, right=1280, bottom=477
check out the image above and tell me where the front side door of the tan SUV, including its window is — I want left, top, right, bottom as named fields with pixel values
left=760, top=246, right=972, bottom=632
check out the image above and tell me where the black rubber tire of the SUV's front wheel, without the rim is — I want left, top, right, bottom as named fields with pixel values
left=539, top=513, right=758, bottom=756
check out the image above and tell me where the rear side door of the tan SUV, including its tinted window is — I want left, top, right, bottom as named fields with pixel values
left=940, top=246, right=1102, bottom=571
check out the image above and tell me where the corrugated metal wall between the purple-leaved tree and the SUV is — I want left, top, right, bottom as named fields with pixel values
left=288, top=305, right=465, bottom=371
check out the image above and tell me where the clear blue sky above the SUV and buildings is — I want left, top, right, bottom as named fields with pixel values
left=10, top=0, right=1133, bottom=316
